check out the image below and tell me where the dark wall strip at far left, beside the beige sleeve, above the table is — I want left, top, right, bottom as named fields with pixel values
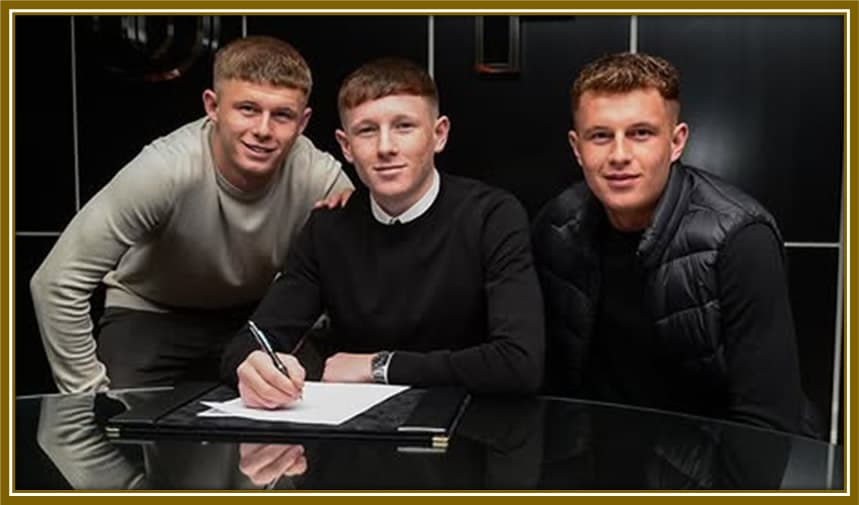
left=15, top=237, right=57, bottom=395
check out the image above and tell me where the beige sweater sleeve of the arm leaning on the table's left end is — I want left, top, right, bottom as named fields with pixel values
left=30, top=148, right=175, bottom=393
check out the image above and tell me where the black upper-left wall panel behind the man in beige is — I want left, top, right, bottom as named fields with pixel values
left=75, top=16, right=241, bottom=204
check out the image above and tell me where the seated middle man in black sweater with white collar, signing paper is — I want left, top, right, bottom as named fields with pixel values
left=222, top=59, right=544, bottom=408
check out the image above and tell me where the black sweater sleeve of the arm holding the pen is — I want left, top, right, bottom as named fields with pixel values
left=221, top=214, right=322, bottom=386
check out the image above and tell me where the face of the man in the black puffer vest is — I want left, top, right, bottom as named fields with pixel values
left=569, top=88, right=689, bottom=231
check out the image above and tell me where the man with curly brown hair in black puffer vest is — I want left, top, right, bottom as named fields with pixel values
left=532, top=53, right=816, bottom=434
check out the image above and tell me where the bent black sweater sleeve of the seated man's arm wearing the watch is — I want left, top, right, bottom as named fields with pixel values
left=388, top=196, right=545, bottom=393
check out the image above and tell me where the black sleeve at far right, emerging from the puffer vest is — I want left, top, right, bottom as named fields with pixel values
left=719, top=224, right=803, bottom=432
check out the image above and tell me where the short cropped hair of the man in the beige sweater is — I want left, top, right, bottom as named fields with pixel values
left=213, top=35, right=313, bottom=98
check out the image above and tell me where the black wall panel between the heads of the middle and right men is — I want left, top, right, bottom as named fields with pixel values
left=435, top=16, right=629, bottom=215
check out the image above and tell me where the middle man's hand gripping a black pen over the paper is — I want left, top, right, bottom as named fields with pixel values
left=236, top=321, right=305, bottom=409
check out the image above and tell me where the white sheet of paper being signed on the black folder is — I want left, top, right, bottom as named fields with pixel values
left=197, top=382, right=409, bottom=424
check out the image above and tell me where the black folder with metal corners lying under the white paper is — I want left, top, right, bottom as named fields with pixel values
left=106, top=383, right=469, bottom=449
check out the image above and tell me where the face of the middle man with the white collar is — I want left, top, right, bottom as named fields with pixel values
left=336, top=95, right=450, bottom=216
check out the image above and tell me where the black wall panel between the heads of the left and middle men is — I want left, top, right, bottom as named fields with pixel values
left=248, top=16, right=428, bottom=184
